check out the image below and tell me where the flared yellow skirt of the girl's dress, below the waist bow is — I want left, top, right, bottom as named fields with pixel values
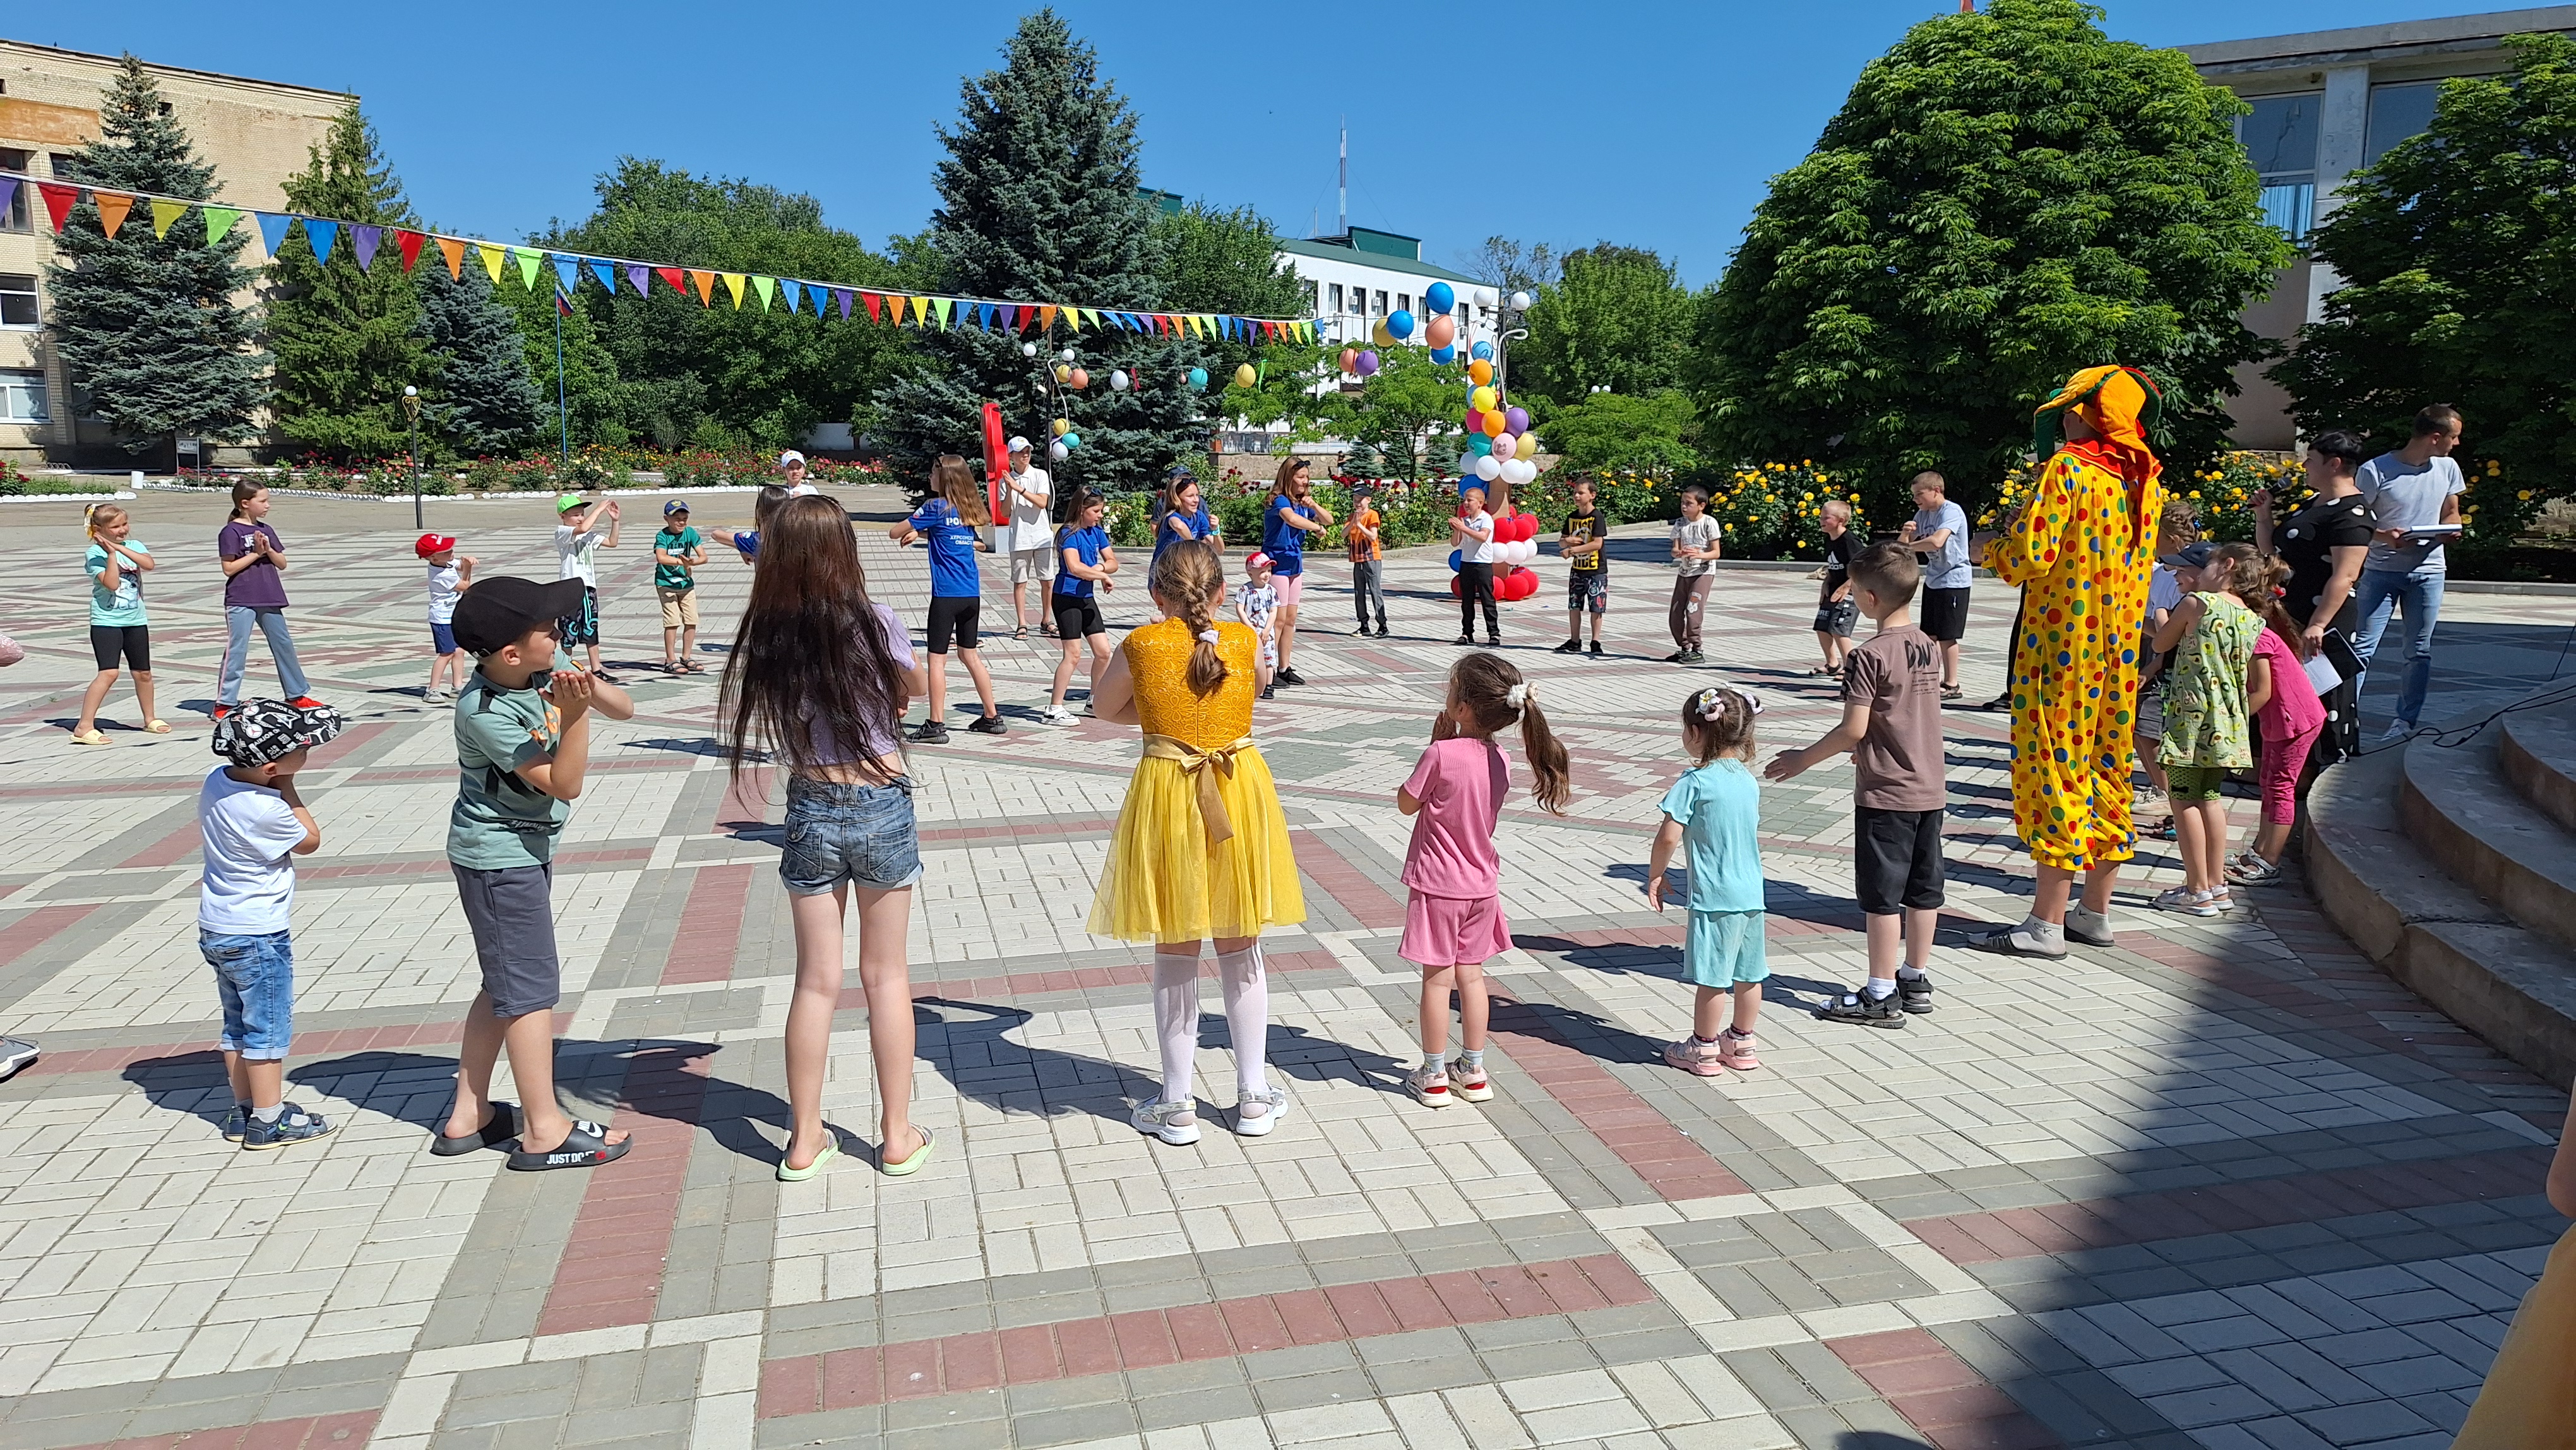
left=1087, top=747, right=1306, bottom=943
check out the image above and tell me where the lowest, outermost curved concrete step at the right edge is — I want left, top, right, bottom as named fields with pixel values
left=2303, top=742, right=2576, bottom=1087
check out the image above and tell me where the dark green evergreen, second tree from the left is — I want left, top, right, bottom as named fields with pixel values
left=268, top=100, right=436, bottom=458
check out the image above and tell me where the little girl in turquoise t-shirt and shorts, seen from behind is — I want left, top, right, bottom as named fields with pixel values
left=1646, top=685, right=1770, bottom=1077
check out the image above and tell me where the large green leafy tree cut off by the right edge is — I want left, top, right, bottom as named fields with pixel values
left=2272, top=36, right=2576, bottom=561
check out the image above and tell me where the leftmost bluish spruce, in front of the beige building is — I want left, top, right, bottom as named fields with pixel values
left=46, top=57, right=268, bottom=453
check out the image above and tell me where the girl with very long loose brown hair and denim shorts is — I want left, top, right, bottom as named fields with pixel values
left=716, top=494, right=930, bottom=1182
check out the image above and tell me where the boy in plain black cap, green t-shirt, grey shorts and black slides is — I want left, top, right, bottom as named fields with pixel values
left=430, top=577, right=636, bottom=1169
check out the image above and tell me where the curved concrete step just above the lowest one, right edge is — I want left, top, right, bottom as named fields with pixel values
left=2398, top=716, right=2576, bottom=948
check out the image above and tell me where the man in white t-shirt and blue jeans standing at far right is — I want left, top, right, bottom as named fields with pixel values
left=2352, top=402, right=2468, bottom=739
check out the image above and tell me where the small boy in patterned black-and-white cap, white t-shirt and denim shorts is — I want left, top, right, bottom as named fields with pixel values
left=196, top=700, right=343, bottom=1149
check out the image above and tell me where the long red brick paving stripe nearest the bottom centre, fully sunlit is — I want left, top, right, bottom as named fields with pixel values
left=752, top=1239, right=1654, bottom=1419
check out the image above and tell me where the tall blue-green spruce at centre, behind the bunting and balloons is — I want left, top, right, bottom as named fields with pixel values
left=873, top=10, right=1221, bottom=497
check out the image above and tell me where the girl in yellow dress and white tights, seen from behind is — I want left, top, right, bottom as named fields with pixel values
left=1090, top=543, right=1306, bottom=1144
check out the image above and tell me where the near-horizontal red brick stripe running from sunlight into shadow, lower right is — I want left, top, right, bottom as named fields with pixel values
left=1916, top=1154, right=2550, bottom=1264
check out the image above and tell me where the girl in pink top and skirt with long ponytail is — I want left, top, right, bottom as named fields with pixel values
left=1396, top=652, right=1571, bottom=1108
